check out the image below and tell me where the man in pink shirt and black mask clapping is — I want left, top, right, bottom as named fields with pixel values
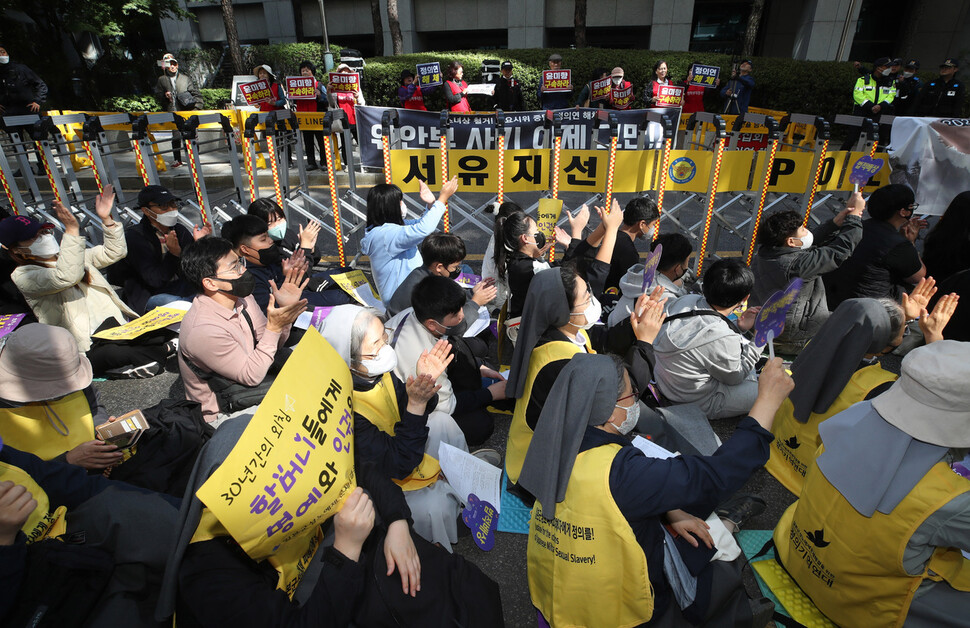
left=179, top=236, right=307, bottom=423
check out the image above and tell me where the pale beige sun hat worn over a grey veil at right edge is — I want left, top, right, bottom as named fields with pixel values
left=872, top=340, right=970, bottom=448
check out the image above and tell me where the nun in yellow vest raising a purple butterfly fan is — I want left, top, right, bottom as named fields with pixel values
left=519, top=354, right=792, bottom=626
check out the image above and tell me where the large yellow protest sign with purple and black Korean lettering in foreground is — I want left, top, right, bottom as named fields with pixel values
left=196, top=328, right=357, bottom=596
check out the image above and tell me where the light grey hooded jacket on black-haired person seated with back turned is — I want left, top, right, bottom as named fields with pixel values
left=653, top=294, right=764, bottom=403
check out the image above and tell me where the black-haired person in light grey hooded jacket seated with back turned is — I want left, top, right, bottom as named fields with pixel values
left=653, top=259, right=764, bottom=419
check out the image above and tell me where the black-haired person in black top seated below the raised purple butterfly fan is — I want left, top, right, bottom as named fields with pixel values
left=822, top=184, right=926, bottom=309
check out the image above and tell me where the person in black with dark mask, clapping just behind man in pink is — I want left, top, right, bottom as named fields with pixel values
left=221, top=214, right=351, bottom=318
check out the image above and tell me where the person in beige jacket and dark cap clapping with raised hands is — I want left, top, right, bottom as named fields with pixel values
left=0, top=186, right=172, bottom=379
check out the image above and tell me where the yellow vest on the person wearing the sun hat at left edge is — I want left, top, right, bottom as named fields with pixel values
left=0, top=391, right=94, bottom=460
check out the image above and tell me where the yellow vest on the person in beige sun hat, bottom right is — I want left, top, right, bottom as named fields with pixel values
left=774, top=462, right=970, bottom=626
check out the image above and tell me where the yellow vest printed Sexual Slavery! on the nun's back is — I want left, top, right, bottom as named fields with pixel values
left=527, top=443, right=653, bottom=628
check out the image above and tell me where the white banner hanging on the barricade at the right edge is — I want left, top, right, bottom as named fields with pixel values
left=889, top=118, right=970, bottom=216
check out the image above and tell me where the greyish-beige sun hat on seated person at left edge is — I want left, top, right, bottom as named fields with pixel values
left=0, top=323, right=93, bottom=403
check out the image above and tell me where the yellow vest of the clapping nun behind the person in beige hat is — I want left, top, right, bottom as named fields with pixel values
left=765, top=364, right=898, bottom=495
